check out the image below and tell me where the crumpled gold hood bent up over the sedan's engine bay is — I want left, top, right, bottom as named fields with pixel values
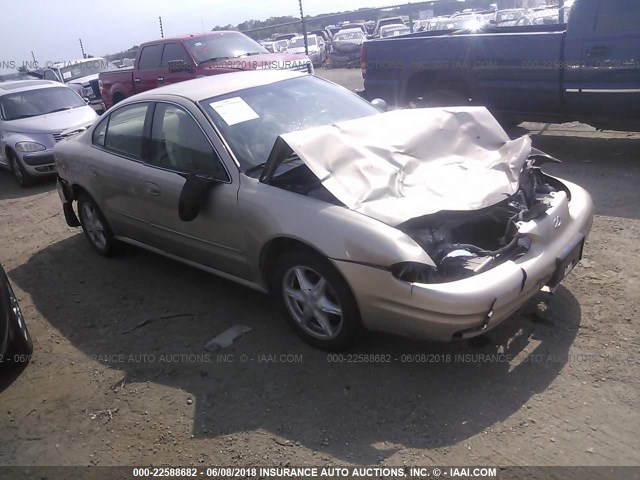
left=281, top=107, right=531, bottom=226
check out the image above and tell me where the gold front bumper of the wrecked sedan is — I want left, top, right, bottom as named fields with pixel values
left=334, top=182, right=593, bottom=341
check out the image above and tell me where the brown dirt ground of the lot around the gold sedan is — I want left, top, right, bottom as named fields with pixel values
left=0, top=121, right=640, bottom=466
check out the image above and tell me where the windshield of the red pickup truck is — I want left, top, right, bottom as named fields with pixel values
left=184, top=32, right=269, bottom=63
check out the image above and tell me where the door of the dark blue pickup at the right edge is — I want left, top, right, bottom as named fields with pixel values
left=567, top=0, right=640, bottom=118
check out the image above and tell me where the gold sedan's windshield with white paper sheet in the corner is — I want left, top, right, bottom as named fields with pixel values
left=200, top=76, right=380, bottom=170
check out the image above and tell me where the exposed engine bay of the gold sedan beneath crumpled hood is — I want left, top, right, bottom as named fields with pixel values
left=394, top=164, right=569, bottom=283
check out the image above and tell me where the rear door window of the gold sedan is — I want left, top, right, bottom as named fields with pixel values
left=104, top=103, right=149, bottom=158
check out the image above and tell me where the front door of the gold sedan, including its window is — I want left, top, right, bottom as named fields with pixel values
left=136, top=103, right=249, bottom=278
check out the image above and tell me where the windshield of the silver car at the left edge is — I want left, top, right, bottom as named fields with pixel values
left=0, top=87, right=86, bottom=120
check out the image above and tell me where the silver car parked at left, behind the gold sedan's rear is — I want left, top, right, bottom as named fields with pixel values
left=0, top=80, right=98, bottom=187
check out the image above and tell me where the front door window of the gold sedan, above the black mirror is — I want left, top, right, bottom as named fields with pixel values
left=148, top=103, right=228, bottom=180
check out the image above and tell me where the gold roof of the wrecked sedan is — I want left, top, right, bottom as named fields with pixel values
left=130, top=69, right=307, bottom=102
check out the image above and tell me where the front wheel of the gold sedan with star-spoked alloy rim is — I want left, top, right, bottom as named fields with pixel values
left=271, top=251, right=362, bottom=350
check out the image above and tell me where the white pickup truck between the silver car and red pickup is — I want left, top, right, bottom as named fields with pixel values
left=34, top=57, right=118, bottom=113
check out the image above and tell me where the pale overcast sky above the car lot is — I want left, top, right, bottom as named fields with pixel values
left=0, top=0, right=396, bottom=73
